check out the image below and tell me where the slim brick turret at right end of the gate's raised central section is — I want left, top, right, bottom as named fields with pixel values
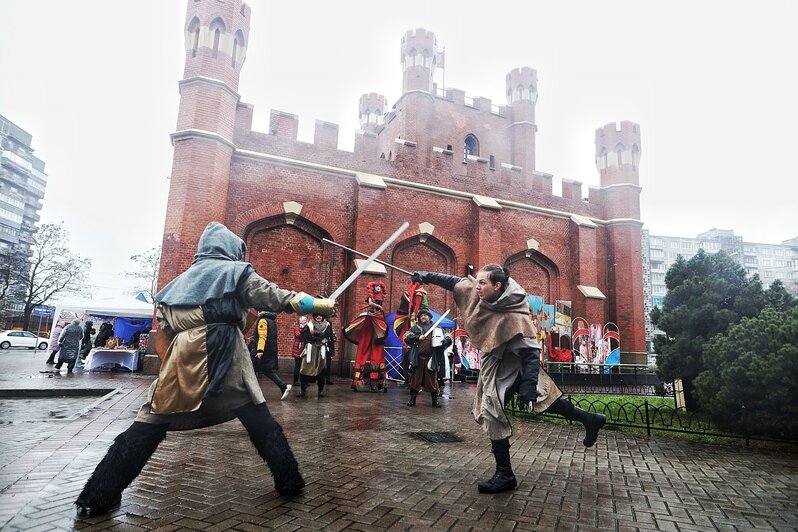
left=506, top=67, right=538, bottom=177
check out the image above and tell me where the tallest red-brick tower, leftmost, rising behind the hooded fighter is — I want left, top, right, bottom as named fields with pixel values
left=158, top=0, right=250, bottom=287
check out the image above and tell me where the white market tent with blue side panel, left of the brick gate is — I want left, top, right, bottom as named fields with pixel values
left=50, top=297, right=155, bottom=341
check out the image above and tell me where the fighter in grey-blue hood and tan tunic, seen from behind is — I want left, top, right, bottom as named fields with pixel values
left=75, top=222, right=335, bottom=516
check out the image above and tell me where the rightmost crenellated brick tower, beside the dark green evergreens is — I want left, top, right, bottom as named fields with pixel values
left=596, top=121, right=646, bottom=356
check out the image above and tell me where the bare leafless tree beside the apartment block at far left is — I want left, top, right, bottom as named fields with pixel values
left=11, top=223, right=91, bottom=331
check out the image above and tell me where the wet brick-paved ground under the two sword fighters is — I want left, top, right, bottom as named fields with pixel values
left=0, top=351, right=798, bottom=531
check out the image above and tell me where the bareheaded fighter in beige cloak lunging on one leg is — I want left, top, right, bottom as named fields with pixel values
left=413, top=264, right=605, bottom=493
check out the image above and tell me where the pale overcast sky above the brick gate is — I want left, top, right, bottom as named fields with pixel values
left=0, top=0, right=798, bottom=296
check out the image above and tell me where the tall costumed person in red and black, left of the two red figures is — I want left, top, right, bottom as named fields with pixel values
left=344, top=281, right=388, bottom=392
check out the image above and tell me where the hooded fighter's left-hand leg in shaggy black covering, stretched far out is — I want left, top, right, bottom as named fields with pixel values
left=75, top=421, right=166, bottom=517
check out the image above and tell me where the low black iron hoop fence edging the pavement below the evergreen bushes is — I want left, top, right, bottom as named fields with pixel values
left=507, top=395, right=798, bottom=447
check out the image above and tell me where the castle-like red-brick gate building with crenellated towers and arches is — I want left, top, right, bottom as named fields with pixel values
left=159, top=0, right=645, bottom=368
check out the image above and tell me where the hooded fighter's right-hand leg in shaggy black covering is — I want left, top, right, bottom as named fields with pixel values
left=235, top=403, right=305, bottom=497
